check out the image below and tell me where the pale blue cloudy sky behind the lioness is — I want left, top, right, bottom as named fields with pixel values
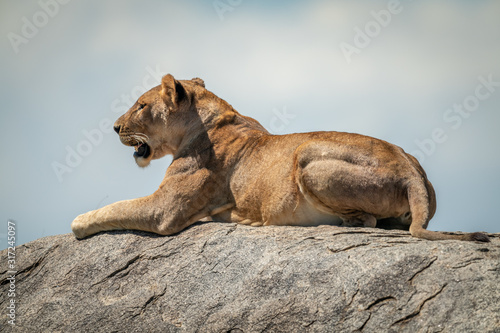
left=0, top=0, right=500, bottom=248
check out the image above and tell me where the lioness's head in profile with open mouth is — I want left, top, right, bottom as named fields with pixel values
left=114, top=74, right=207, bottom=167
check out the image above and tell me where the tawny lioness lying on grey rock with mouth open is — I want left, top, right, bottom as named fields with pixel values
left=71, top=75, right=489, bottom=242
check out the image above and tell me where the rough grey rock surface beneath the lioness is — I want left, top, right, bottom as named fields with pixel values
left=0, top=223, right=500, bottom=332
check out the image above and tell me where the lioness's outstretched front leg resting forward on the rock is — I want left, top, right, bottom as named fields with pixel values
left=71, top=170, right=234, bottom=238
